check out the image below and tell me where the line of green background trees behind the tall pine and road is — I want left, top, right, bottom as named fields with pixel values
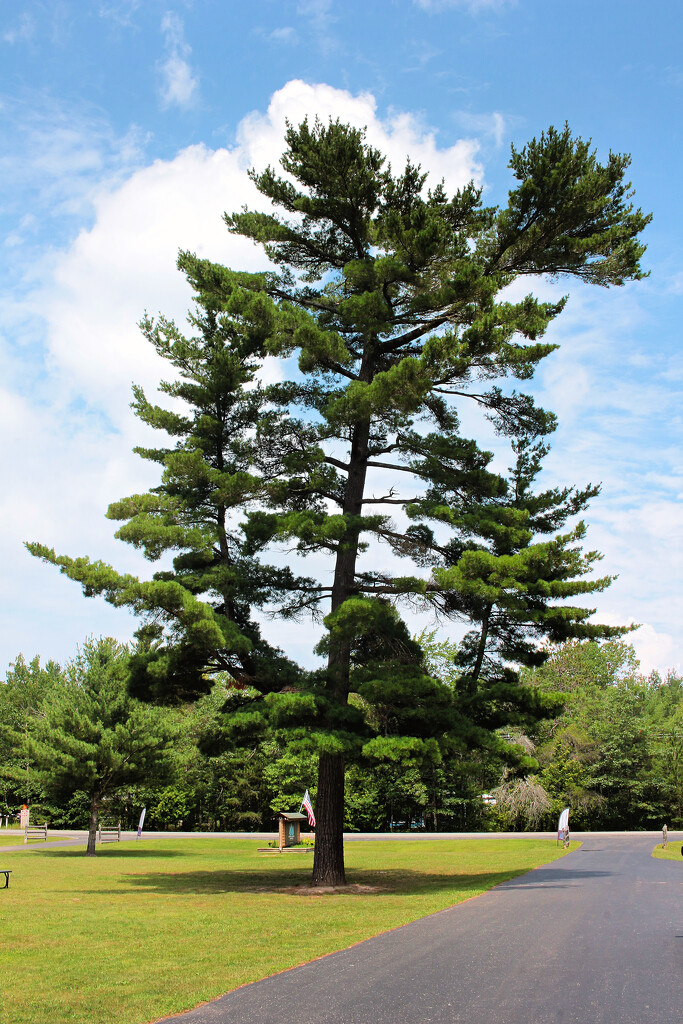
left=0, top=634, right=683, bottom=831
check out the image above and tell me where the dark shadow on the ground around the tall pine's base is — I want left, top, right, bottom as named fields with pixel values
left=80, top=868, right=610, bottom=898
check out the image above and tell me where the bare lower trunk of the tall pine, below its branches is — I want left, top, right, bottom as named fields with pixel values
left=312, top=754, right=346, bottom=886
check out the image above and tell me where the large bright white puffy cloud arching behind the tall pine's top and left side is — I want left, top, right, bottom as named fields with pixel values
left=30, top=81, right=481, bottom=423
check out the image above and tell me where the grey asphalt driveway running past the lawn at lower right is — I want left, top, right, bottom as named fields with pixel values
left=162, top=835, right=683, bottom=1024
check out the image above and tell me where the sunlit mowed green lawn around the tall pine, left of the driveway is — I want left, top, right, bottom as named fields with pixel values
left=0, top=838, right=579, bottom=1024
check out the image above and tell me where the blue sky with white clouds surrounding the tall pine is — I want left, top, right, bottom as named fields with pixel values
left=0, top=0, right=683, bottom=671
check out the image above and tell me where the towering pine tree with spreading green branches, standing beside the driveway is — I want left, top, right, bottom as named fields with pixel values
left=30, top=122, right=648, bottom=884
